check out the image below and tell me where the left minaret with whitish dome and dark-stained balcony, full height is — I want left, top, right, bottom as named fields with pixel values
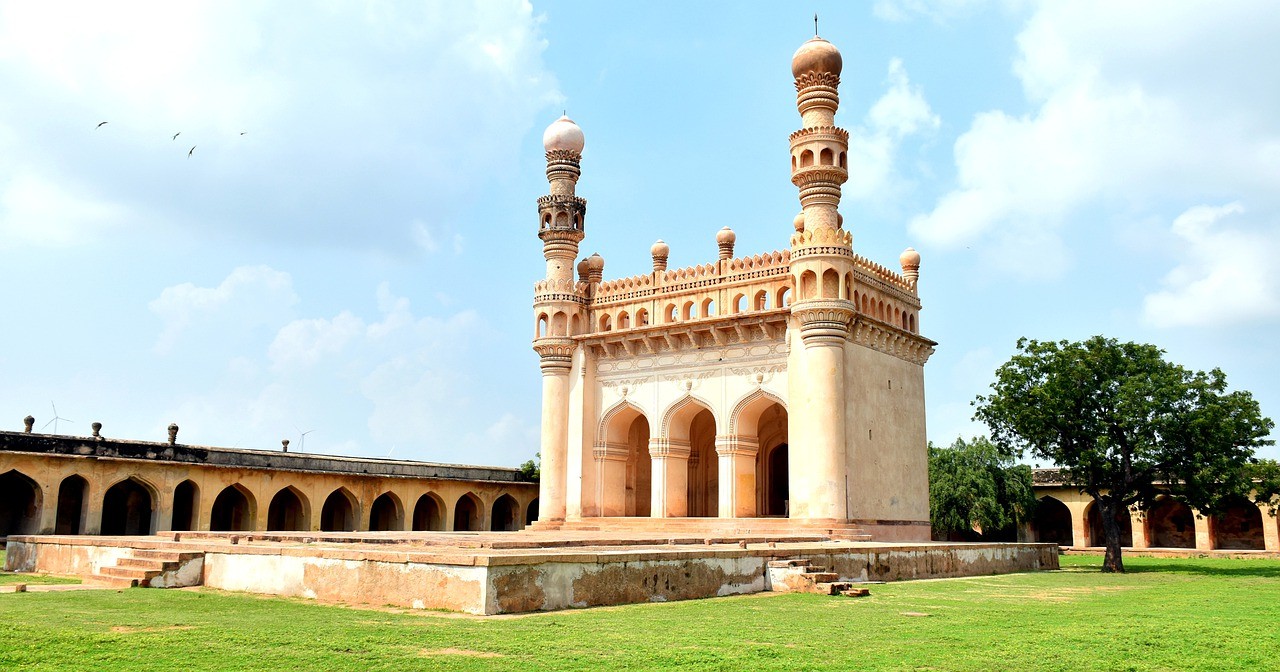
left=534, top=116, right=586, bottom=525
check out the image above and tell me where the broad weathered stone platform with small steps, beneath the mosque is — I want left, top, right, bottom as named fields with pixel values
left=5, top=531, right=1059, bottom=614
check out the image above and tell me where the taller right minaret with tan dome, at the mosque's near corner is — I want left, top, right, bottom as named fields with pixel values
left=788, top=36, right=855, bottom=520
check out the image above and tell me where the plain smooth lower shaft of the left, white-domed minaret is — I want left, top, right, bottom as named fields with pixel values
left=534, top=338, right=575, bottom=522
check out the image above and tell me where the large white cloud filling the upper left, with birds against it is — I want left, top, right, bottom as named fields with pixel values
left=0, top=0, right=559, bottom=253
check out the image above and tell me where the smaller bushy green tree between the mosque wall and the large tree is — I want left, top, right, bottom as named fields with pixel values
left=929, top=436, right=1036, bottom=539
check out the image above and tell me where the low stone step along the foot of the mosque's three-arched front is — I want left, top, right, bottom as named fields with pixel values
left=527, top=516, right=872, bottom=541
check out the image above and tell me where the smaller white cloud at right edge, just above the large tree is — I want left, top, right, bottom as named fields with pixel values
left=1143, top=202, right=1280, bottom=328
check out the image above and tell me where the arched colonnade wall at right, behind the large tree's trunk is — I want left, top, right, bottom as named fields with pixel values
left=1029, top=485, right=1280, bottom=552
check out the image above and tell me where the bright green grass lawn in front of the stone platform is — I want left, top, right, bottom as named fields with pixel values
left=0, top=557, right=1280, bottom=671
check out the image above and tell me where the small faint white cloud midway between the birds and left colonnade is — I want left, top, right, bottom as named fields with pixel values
left=147, top=266, right=298, bottom=353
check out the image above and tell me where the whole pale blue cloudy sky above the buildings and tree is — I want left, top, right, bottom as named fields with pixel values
left=0, top=0, right=1280, bottom=465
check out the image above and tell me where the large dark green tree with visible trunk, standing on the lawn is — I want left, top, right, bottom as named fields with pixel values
left=974, top=337, right=1275, bottom=572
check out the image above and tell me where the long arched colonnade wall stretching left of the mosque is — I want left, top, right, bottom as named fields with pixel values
left=0, top=435, right=538, bottom=536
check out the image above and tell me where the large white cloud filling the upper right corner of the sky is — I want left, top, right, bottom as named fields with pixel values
left=910, top=0, right=1280, bottom=276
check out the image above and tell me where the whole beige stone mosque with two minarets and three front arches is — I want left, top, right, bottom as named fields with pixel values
left=524, top=37, right=936, bottom=540
